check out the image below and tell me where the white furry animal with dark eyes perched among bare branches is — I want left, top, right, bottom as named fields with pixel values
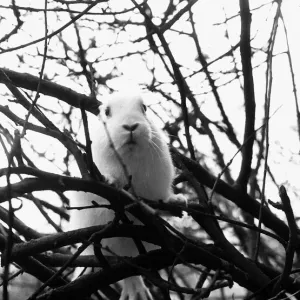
left=71, top=93, right=184, bottom=300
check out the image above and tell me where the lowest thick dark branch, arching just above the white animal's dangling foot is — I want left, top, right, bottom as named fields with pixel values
left=37, top=247, right=255, bottom=300
